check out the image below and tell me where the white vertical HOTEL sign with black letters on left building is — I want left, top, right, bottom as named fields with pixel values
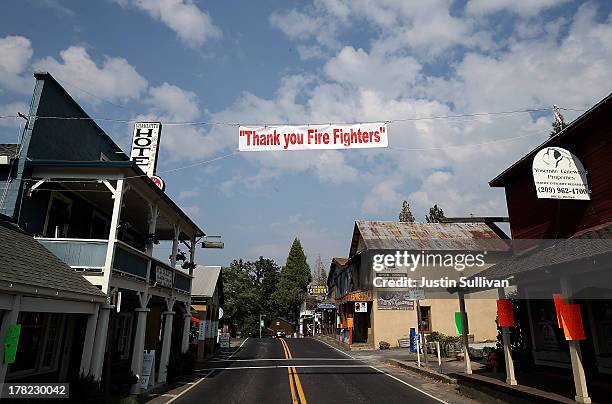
left=130, top=122, right=161, bottom=177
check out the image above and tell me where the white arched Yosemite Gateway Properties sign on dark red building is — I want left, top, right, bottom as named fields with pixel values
left=532, top=147, right=591, bottom=201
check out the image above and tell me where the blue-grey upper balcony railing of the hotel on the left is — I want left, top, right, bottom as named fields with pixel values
left=37, top=238, right=191, bottom=293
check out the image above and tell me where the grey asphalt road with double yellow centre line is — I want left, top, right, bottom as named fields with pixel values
left=161, top=338, right=460, bottom=404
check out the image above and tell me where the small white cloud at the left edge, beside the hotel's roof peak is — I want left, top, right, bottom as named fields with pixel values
left=0, top=36, right=34, bottom=94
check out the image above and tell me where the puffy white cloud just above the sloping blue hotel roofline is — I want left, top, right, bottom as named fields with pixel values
left=34, top=46, right=147, bottom=104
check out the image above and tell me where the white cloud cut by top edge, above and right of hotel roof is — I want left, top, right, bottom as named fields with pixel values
left=115, top=0, right=222, bottom=46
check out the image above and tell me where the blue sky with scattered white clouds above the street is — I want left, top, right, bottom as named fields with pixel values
left=0, top=0, right=612, bottom=272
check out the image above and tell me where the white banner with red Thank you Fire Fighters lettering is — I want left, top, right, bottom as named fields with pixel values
left=238, top=122, right=388, bottom=151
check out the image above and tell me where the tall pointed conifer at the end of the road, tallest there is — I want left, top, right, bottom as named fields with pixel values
left=272, top=237, right=312, bottom=326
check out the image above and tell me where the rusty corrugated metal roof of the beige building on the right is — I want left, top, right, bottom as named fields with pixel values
left=349, top=220, right=508, bottom=257
